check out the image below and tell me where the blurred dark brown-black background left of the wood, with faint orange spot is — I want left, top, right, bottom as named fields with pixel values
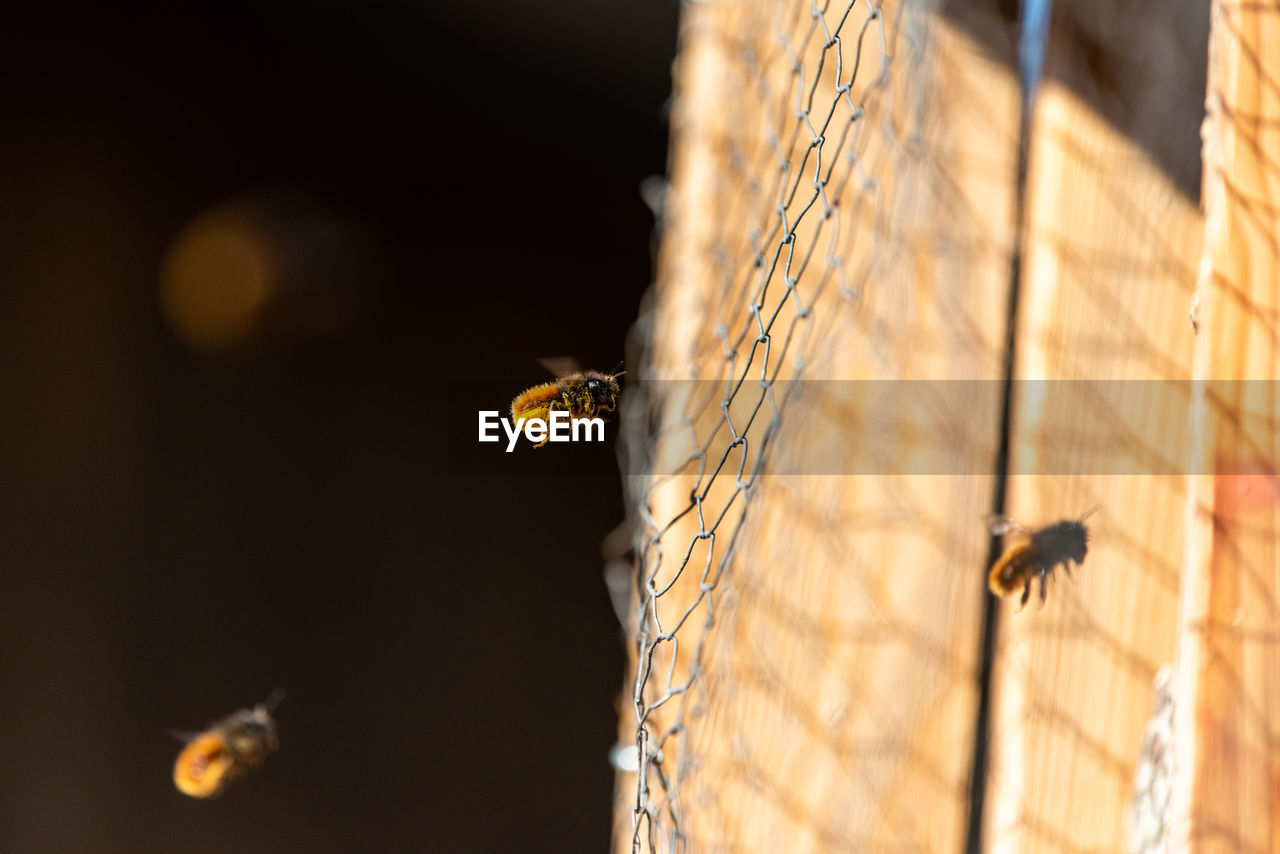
left=0, top=0, right=677, bottom=854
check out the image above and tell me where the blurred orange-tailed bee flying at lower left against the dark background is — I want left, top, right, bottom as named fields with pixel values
left=173, top=689, right=284, bottom=798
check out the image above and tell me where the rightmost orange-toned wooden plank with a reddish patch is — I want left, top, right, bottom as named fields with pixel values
left=1171, top=3, right=1280, bottom=853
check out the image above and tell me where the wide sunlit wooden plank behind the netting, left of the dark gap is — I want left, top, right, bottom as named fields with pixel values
left=616, top=0, right=1018, bottom=851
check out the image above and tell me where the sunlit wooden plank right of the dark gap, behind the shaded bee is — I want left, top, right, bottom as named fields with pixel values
left=986, top=60, right=1202, bottom=851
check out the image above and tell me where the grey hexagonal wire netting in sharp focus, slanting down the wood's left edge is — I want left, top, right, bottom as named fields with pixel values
left=631, top=3, right=890, bottom=851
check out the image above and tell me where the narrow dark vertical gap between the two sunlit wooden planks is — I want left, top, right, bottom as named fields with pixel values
left=965, top=4, right=1048, bottom=854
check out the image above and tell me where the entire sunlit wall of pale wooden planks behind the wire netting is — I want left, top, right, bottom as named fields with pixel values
left=616, top=0, right=1280, bottom=851
